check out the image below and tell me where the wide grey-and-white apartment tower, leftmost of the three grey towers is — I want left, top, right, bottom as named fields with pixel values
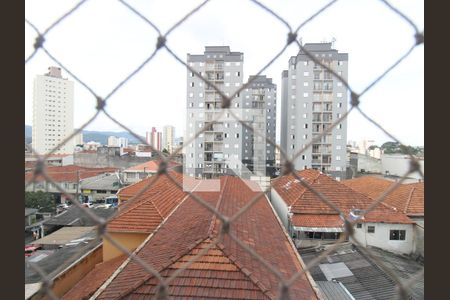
left=184, top=46, right=244, bottom=178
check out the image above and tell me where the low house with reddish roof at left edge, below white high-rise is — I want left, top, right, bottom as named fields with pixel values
left=25, top=165, right=116, bottom=203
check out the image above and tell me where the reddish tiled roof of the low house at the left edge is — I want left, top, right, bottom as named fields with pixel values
left=25, top=165, right=117, bottom=182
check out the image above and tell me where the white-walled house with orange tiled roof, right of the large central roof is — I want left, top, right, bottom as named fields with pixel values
left=271, top=169, right=415, bottom=254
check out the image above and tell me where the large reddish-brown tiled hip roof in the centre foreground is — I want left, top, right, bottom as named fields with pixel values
left=98, top=176, right=317, bottom=299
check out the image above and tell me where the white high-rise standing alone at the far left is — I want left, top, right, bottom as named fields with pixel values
left=32, top=67, right=75, bottom=154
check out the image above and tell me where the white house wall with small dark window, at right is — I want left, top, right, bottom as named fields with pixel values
left=350, top=223, right=415, bottom=254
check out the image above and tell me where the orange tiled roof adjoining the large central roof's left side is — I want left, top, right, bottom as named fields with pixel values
left=108, top=172, right=186, bottom=233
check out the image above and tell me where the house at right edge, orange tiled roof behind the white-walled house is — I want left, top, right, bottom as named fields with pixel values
left=342, top=176, right=425, bottom=257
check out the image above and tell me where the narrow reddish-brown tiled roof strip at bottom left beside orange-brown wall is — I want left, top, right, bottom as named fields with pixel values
left=61, top=255, right=127, bottom=300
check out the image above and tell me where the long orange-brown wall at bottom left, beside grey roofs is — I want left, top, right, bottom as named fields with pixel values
left=37, top=245, right=103, bottom=299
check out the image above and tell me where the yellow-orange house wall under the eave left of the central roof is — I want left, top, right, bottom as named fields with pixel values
left=103, top=232, right=149, bottom=261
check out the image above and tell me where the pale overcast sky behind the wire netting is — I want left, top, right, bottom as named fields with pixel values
left=25, top=0, right=424, bottom=146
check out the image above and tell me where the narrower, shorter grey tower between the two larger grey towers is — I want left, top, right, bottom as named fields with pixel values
left=242, top=75, right=277, bottom=176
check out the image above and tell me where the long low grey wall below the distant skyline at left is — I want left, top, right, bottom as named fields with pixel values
left=74, top=153, right=149, bottom=168
